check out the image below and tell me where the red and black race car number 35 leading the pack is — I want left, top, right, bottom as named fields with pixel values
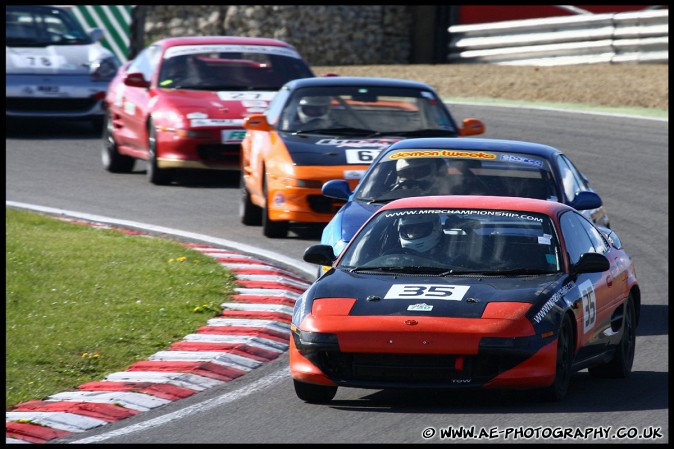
left=290, top=195, right=641, bottom=403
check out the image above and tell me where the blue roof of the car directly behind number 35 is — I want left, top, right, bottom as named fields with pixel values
left=380, top=137, right=563, bottom=159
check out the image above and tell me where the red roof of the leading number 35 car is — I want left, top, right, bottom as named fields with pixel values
left=375, top=195, right=574, bottom=216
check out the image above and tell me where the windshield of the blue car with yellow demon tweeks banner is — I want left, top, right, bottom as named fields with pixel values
left=354, top=149, right=560, bottom=203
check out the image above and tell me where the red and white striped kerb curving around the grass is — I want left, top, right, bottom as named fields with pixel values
left=5, top=217, right=310, bottom=444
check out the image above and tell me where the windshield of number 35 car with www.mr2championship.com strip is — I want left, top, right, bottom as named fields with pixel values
left=337, top=209, right=562, bottom=275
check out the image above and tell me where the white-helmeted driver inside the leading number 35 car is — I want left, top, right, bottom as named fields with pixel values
left=398, top=214, right=443, bottom=257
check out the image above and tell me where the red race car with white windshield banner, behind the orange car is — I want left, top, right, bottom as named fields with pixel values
left=102, top=36, right=314, bottom=184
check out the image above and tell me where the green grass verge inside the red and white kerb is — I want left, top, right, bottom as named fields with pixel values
left=5, top=208, right=235, bottom=410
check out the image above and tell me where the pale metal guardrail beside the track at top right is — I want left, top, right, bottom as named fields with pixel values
left=447, top=9, right=669, bottom=66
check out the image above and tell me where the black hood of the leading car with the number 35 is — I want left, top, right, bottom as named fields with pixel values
left=306, top=270, right=565, bottom=318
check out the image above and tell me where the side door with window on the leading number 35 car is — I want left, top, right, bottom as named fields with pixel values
left=559, top=210, right=620, bottom=358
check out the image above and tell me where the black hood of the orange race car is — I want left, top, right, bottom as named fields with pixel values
left=279, top=132, right=403, bottom=165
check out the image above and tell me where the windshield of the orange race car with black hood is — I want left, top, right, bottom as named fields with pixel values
left=278, top=85, right=457, bottom=137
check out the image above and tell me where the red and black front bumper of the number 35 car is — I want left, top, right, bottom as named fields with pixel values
left=290, top=317, right=557, bottom=388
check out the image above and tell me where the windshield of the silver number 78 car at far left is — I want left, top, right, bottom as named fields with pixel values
left=5, top=6, right=91, bottom=47
